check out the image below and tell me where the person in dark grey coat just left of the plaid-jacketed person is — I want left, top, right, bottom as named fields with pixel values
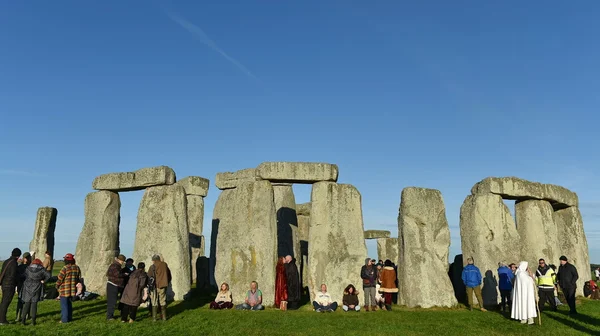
left=21, top=259, right=50, bottom=325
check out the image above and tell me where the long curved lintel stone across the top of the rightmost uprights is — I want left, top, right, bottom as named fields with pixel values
left=471, top=177, right=579, bottom=208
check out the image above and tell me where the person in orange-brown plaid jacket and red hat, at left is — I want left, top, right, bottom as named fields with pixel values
left=56, top=253, right=81, bottom=323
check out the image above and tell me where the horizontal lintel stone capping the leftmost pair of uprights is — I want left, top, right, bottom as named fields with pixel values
left=92, top=166, right=175, bottom=191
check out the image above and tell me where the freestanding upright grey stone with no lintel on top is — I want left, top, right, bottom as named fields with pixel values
left=398, top=187, right=457, bottom=308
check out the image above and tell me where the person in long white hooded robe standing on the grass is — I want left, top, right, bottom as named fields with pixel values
left=510, top=261, right=537, bottom=324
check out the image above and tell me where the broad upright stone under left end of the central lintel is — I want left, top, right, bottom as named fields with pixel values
left=211, top=181, right=277, bottom=306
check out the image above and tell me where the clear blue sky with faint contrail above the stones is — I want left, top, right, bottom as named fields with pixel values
left=0, top=1, right=600, bottom=263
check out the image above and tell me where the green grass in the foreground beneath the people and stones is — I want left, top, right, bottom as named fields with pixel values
left=0, top=288, right=600, bottom=336
